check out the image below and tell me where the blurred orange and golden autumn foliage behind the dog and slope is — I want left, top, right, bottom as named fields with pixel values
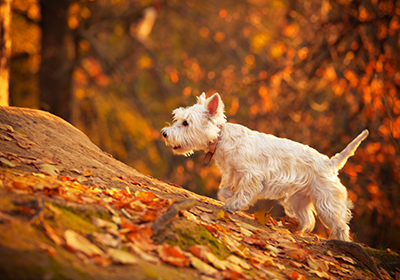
left=10, top=0, right=400, bottom=249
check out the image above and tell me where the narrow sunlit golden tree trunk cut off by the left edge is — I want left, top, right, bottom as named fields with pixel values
left=0, top=0, right=11, bottom=106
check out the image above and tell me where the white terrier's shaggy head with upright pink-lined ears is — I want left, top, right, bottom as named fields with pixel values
left=161, top=93, right=226, bottom=156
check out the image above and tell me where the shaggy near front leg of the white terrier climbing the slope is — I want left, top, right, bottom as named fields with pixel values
left=218, top=175, right=261, bottom=213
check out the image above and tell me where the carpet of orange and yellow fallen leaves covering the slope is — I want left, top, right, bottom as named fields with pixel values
left=0, top=154, right=396, bottom=279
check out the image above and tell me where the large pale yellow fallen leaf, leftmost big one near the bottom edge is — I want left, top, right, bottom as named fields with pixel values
left=64, top=229, right=103, bottom=256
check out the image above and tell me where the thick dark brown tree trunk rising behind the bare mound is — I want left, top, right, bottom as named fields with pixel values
left=39, top=0, right=75, bottom=121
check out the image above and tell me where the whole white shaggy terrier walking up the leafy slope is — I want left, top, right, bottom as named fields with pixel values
left=162, top=93, right=368, bottom=241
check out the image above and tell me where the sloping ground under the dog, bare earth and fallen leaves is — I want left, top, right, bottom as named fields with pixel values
left=0, top=107, right=400, bottom=280
